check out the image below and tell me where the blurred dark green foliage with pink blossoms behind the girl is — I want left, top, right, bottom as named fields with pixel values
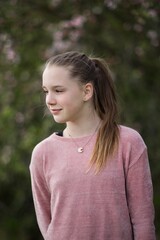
left=0, top=0, right=160, bottom=240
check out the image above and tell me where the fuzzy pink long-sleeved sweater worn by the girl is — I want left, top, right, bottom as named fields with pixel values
left=30, top=126, right=155, bottom=240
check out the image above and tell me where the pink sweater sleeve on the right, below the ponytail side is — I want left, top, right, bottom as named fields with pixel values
left=126, top=136, right=156, bottom=240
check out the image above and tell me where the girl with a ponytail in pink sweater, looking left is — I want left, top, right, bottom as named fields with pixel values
left=30, top=52, right=155, bottom=240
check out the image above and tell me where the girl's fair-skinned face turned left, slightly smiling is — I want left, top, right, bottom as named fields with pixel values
left=42, top=65, right=90, bottom=123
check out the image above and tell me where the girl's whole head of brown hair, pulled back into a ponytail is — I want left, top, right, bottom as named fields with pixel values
left=47, top=51, right=119, bottom=173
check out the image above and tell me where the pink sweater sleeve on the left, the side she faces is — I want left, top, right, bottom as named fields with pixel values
left=30, top=145, right=51, bottom=239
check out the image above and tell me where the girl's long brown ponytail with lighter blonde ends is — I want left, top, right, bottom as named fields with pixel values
left=90, top=58, right=119, bottom=173
